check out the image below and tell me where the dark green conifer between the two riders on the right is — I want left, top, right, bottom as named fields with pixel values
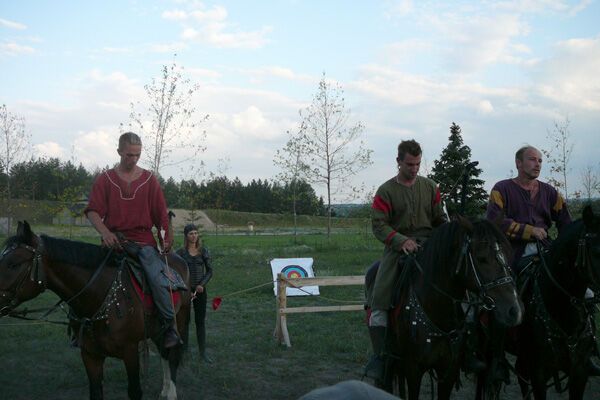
left=428, top=122, right=487, bottom=216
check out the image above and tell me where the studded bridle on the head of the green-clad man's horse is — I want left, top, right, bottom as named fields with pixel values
left=455, top=235, right=514, bottom=311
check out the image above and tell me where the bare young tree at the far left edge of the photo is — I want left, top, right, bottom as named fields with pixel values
left=0, top=104, right=31, bottom=233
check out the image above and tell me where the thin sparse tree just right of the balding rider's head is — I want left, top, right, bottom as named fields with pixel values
left=541, top=117, right=573, bottom=200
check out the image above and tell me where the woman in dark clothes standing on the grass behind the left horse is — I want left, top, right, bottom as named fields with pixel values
left=177, top=224, right=212, bottom=364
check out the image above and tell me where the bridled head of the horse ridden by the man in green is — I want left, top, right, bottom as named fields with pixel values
left=456, top=220, right=523, bottom=326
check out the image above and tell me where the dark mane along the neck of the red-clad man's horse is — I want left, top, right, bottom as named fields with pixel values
left=41, top=235, right=109, bottom=269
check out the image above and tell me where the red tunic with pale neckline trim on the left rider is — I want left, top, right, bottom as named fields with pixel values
left=84, top=169, right=170, bottom=247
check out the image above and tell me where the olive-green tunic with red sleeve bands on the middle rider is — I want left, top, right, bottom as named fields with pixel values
left=371, top=176, right=445, bottom=251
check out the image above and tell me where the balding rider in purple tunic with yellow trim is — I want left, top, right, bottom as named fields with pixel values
left=487, top=145, right=600, bottom=376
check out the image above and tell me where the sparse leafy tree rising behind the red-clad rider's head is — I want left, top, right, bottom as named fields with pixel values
left=121, top=57, right=208, bottom=175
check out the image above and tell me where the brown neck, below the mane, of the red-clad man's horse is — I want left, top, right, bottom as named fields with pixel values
left=44, top=260, right=114, bottom=316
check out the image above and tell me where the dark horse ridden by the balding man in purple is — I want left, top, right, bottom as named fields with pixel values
left=508, top=206, right=600, bottom=400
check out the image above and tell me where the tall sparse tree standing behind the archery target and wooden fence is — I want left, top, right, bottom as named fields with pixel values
left=295, top=74, right=372, bottom=237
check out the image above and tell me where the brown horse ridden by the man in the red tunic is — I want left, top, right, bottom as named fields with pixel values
left=0, top=222, right=190, bottom=400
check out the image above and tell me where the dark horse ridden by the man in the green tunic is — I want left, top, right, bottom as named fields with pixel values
left=364, top=219, right=522, bottom=400
